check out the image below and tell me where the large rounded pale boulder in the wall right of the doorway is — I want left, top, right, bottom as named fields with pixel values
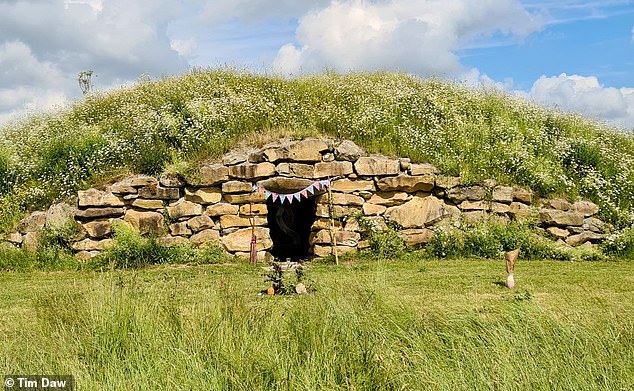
left=385, top=196, right=445, bottom=228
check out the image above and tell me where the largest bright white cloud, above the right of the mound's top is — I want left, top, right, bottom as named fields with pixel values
left=274, top=0, right=543, bottom=75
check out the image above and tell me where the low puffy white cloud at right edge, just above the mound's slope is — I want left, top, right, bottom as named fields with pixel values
left=529, top=73, right=634, bottom=129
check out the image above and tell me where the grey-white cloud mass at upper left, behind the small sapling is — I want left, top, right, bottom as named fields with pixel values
left=0, top=0, right=188, bottom=123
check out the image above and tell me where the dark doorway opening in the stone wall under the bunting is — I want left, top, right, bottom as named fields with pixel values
left=266, top=197, right=317, bottom=261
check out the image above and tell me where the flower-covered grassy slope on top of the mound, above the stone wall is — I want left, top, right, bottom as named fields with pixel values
left=0, top=70, right=634, bottom=232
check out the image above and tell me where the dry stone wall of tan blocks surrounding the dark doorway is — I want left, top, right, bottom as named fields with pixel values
left=2, top=139, right=609, bottom=260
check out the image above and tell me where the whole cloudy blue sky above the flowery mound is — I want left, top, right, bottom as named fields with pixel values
left=0, top=0, right=634, bottom=129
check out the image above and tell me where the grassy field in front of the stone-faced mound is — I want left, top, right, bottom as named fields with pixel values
left=0, top=260, right=634, bottom=390
